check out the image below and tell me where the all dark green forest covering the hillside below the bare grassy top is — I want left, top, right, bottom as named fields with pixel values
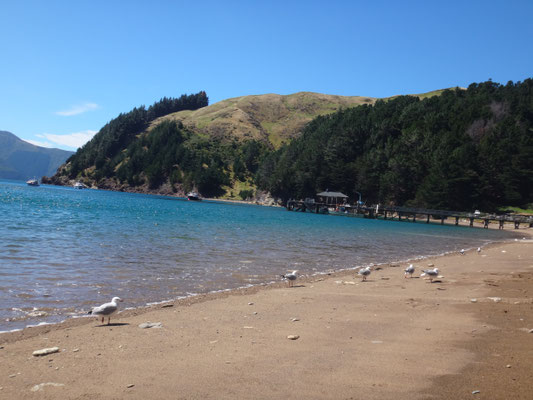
left=53, top=79, right=533, bottom=211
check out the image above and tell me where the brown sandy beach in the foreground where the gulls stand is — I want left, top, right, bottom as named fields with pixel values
left=0, top=234, right=533, bottom=399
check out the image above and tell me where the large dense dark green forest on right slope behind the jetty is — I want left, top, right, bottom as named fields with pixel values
left=255, top=79, right=533, bottom=211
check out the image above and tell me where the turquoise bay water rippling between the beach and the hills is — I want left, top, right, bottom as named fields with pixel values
left=0, top=181, right=515, bottom=331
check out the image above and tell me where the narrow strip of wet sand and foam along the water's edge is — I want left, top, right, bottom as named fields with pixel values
left=0, top=238, right=533, bottom=344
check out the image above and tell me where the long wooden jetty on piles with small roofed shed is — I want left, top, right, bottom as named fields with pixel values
left=286, top=199, right=533, bottom=229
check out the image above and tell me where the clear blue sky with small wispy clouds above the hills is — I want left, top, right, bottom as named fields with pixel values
left=0, top=0, right=533, bottom=151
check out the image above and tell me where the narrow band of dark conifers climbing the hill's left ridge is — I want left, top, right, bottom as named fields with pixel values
left=67, top=91, right=208, bottom=180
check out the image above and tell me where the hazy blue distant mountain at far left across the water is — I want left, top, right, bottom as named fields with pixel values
left=0, top=131, right=74, bottom=180
